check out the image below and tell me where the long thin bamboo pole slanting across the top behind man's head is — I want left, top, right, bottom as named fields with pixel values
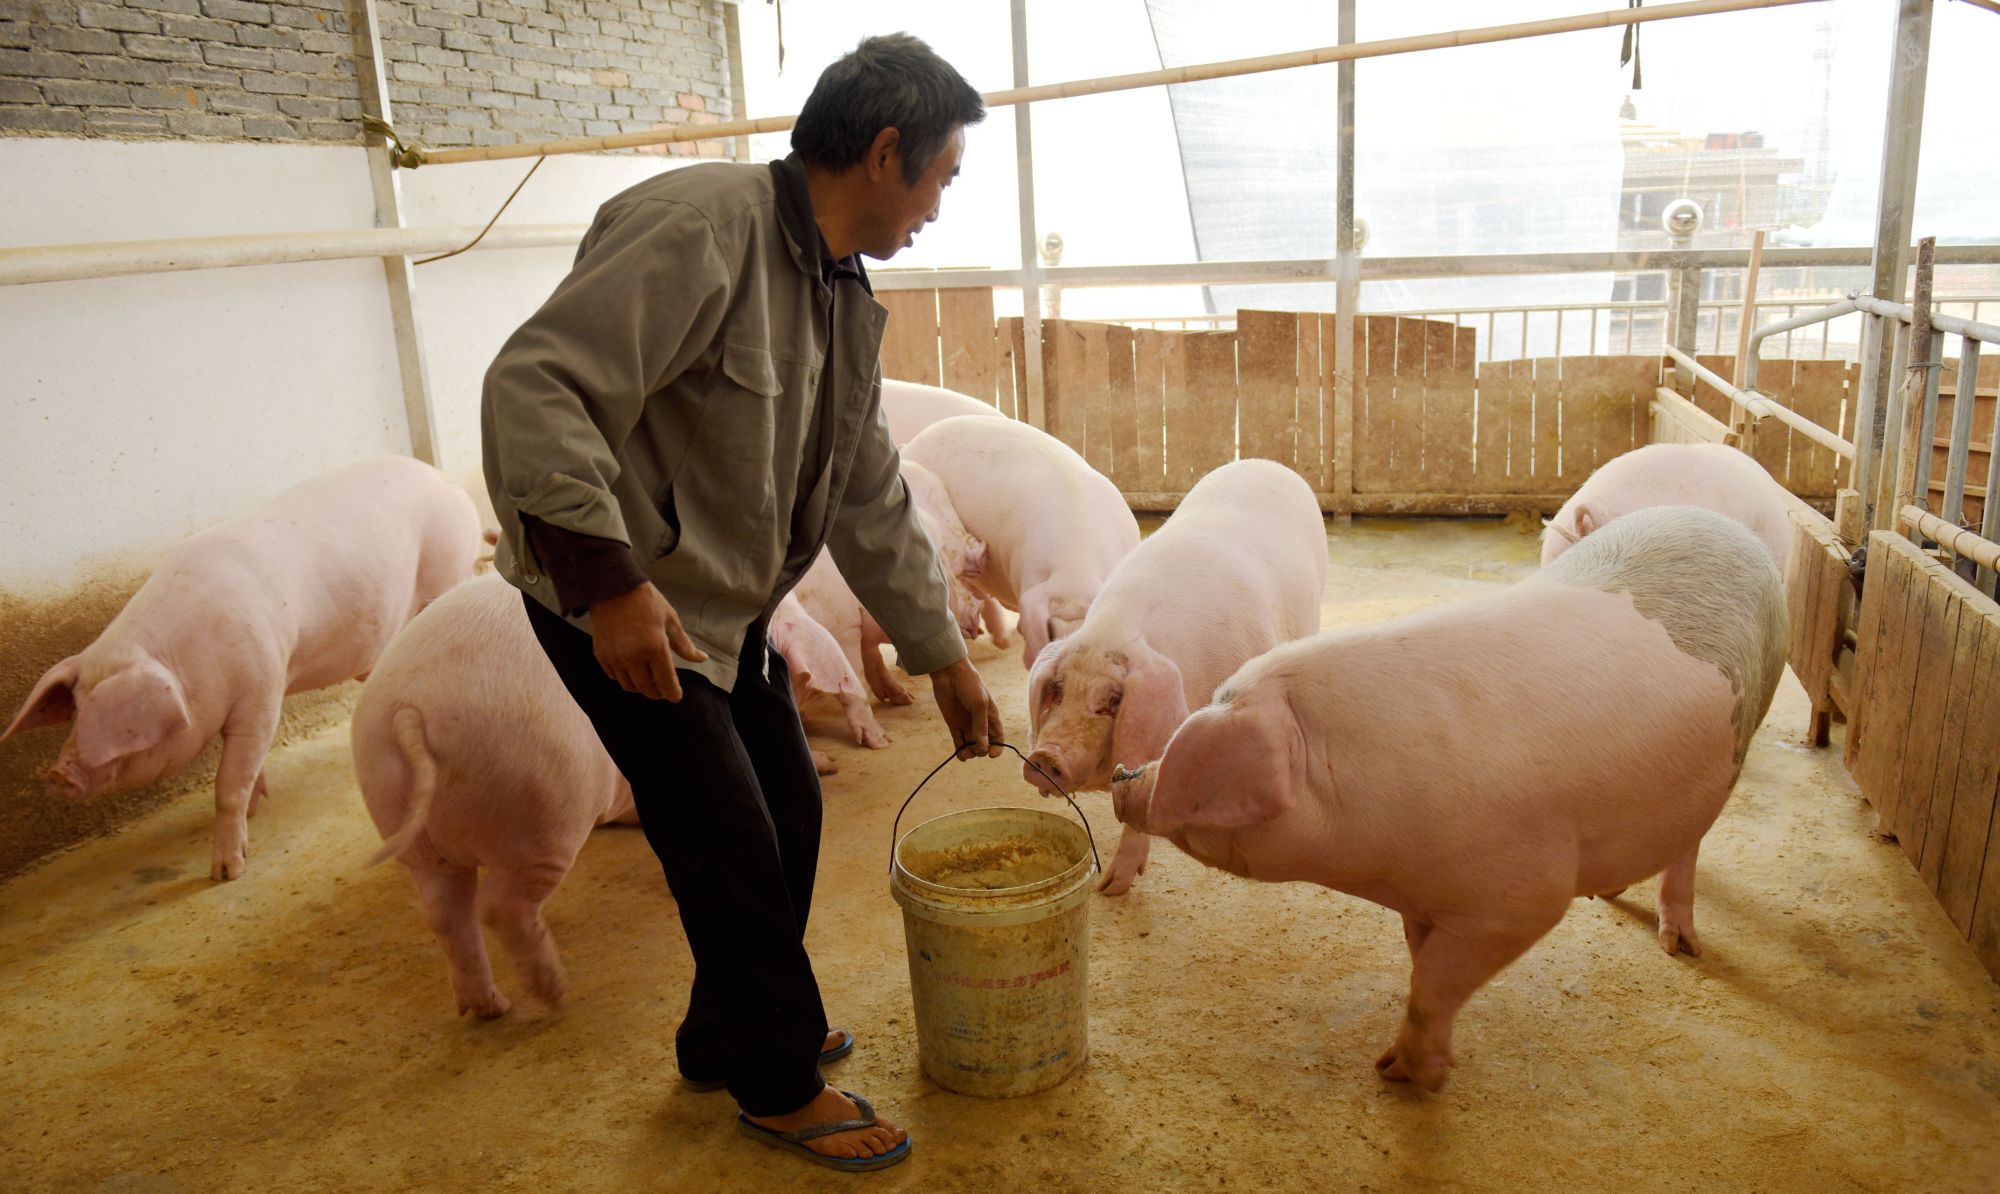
left=400, top=0, right=1824, bottom=168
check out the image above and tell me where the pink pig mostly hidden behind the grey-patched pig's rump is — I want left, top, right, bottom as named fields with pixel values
left=1542, top=444, right=1792, bottom=570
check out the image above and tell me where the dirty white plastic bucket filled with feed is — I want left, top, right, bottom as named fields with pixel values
left=890, top=808, right=1096, bottom=1098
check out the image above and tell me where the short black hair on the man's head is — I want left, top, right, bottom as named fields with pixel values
left=792, top=34, right=986, bottom=182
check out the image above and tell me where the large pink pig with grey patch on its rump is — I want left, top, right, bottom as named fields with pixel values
left=1112, top=506, right=1786, bottom=1090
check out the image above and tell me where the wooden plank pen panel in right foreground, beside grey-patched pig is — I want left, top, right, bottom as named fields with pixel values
left=1846, top=532, right=2000, bottom=978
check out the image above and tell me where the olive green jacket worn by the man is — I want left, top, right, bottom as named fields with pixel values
left=482, top=160, right=966, bottom=690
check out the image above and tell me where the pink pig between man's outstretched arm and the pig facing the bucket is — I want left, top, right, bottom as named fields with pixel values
left=904, top=416, right=1138, bottom=666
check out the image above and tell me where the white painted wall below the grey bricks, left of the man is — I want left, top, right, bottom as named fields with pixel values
left=0, top=138, right=682, bottom=594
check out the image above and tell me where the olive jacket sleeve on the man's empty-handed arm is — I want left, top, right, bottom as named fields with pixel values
left=480, top=200, right=730, bottom=548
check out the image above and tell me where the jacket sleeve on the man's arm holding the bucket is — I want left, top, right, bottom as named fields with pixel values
left=826, top=384, right=966, bottom=676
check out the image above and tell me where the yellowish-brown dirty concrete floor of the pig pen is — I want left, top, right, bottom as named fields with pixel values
left=0, top=522, right=2000, bottom=1192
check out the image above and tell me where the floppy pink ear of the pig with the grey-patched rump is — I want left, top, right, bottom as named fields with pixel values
left=1146, top=700, right=1302, bottom=836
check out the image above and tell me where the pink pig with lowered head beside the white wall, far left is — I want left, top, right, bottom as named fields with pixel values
left=0, top=456, right=480, bottom=880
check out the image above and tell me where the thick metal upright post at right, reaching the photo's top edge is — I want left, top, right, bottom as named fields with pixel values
left=1856, top=0, right=1932, bottom=530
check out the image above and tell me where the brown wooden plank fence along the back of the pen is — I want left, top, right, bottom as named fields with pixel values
left=882, top=288, right=1852, bottom=514
